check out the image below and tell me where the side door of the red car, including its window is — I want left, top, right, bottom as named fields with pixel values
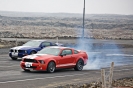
left=59, top=49, right=75, bottom=66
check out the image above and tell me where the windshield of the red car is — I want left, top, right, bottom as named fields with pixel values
left=37, top=47, right=60, bottom=56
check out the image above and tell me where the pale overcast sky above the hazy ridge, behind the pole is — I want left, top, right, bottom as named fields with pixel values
left=0, top=0, right=133, bottom=15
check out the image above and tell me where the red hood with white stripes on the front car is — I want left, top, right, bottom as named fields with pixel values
left=23, top=54, right=56, bottom=60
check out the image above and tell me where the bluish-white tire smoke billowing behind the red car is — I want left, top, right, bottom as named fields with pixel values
left=68, top=28, right=122, bottom=70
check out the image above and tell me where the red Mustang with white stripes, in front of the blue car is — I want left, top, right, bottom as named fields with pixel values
left=20, top=46, right=88, bottom=73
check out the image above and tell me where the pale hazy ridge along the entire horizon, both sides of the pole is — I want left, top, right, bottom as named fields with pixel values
left=0, top=11, right=133, bottom=18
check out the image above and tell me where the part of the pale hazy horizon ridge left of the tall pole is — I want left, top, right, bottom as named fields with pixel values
left=0, top=11, right=82, bottom=17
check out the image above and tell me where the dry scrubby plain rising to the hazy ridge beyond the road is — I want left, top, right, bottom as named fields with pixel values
left=0, top=11, right=133, bottom=39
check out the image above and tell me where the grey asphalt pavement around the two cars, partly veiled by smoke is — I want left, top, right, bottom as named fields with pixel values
left=0, top=40, right=133, bottom=88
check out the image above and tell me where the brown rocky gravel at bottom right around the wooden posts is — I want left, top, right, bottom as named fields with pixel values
left=55, top=78, right=133, bottom=88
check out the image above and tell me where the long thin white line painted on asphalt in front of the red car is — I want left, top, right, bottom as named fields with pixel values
left=0, top=73, right=88, bottom=83
